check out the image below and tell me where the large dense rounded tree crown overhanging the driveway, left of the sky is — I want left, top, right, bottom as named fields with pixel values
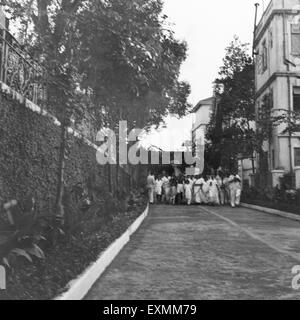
left=79, top=0, right=190, bottom=128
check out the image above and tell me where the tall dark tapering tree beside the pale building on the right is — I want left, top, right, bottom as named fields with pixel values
left=207, top=37, right=256, bottom=171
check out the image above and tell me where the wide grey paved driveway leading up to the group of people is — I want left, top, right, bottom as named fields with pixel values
left=86, top=206, right=300, bottom=300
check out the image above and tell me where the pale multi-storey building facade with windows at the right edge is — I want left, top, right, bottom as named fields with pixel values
left=254, top=0, right=300, bottom=188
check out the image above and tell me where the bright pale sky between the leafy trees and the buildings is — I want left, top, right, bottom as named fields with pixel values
left=145, top=0, right=269, bottom=150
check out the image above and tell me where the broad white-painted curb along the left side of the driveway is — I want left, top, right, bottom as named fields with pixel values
left=54, top=205, right=149, bottom=300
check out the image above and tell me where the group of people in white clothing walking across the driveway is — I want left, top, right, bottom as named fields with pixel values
left=147, top=172, right=242, bottom=208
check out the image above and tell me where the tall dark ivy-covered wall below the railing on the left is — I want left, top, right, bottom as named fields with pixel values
left=0, top=93, right=109, bottom=213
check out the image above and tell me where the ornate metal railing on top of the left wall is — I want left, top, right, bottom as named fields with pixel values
left=0, top=26, right=47, bottom=105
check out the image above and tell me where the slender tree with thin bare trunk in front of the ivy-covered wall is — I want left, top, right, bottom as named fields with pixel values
left=2, top=0, right=89, bottom=223
